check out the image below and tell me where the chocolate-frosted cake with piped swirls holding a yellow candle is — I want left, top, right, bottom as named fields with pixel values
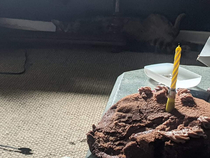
left=87, top=86, right=210, bottom=158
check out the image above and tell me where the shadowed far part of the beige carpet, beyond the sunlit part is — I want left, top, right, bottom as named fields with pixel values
left=0, top=39, right=202, bottom=95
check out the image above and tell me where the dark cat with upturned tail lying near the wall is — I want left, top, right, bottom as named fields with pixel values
left=123, top=13, right=185, bottom=52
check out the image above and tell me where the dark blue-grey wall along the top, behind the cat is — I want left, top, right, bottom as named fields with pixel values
left=0, top=0, right=210, bottom=31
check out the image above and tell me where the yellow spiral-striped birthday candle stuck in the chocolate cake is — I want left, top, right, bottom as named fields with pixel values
left=166, top=45, right=182, bottom=112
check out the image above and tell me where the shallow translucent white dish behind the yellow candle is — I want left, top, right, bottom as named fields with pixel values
left=144, top=63, right=202, bottom=88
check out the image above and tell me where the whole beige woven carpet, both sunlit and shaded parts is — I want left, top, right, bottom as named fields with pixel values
left=0, top=47, right=203, bottom=158
